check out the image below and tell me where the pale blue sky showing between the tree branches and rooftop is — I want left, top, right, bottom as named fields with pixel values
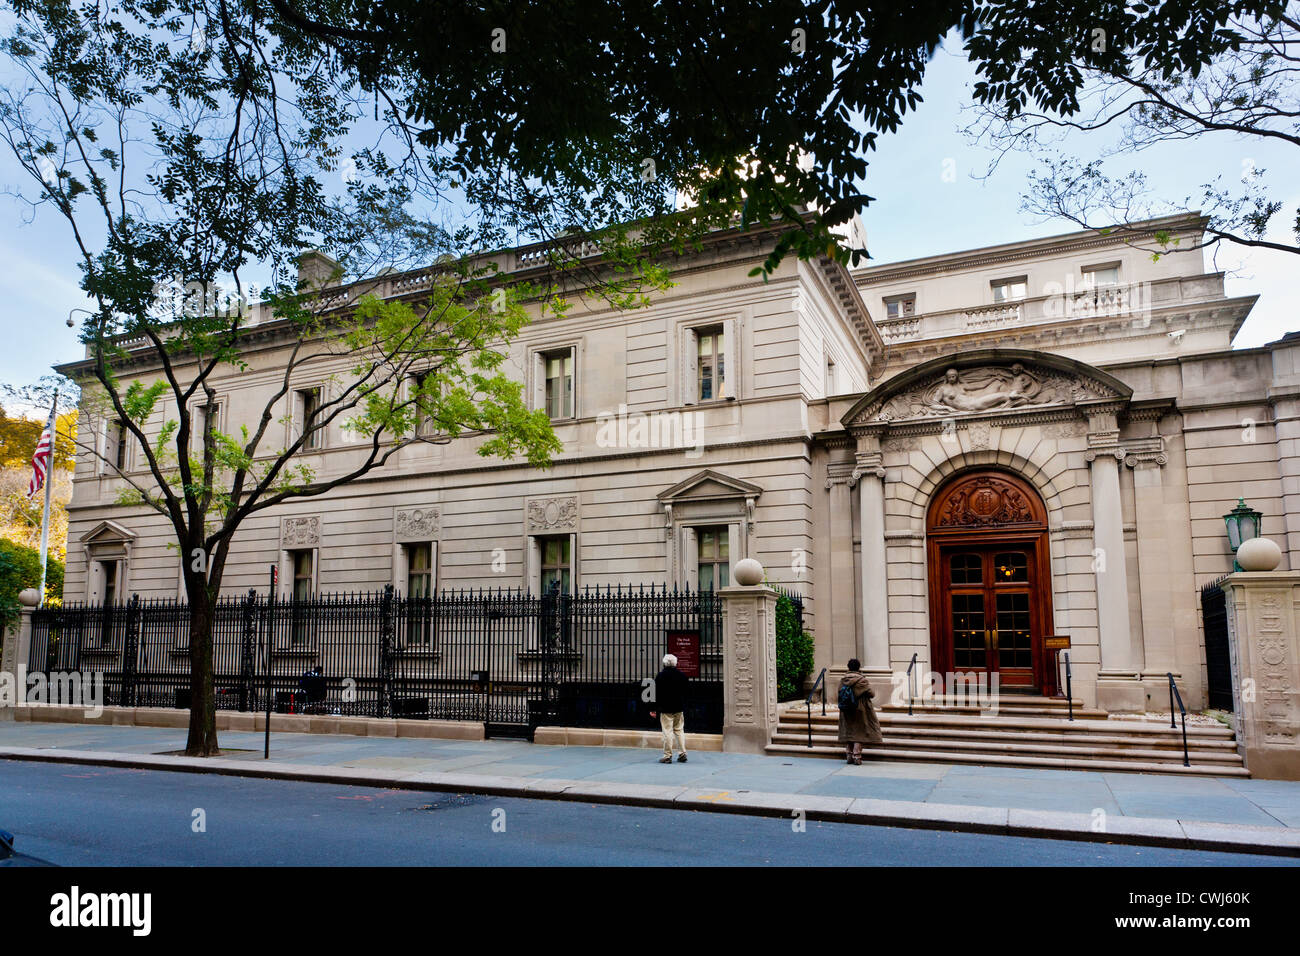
left=0, top=29, right=1300, bottom=398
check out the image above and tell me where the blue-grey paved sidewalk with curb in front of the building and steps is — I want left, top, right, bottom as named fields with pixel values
left=0, top=722, right=1300, bottom=856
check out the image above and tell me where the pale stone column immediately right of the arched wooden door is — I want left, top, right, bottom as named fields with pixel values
left=1086, top=407, right=1147, bottom=711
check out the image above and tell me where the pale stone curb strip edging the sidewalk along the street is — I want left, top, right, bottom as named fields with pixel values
left=0, top=747, right=1300, bottom=857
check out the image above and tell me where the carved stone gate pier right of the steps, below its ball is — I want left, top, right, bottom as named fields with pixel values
left=1223, top=571, right=1300, bottom=780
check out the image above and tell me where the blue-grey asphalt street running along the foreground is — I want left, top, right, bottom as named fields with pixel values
left=0, top=761, right=1300, bottom=866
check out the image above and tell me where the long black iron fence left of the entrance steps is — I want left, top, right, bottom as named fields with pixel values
left=29, top=587, right=743, bottom=732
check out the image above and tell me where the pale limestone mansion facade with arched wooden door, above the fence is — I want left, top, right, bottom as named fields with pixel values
left=65, top=219, right=1300, bottom=711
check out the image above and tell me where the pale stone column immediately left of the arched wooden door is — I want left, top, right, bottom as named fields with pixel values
left=857, top=434, right=892, bottom=695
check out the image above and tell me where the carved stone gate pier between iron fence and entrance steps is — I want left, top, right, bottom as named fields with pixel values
left=718, top=574, right=776, bottom=753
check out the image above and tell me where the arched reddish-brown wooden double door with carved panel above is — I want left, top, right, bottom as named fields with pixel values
left=926, top=470, right=1056, bottom=693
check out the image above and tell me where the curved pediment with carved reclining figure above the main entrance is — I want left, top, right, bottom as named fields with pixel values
left=840, top=349, right=1132, bottom=428
